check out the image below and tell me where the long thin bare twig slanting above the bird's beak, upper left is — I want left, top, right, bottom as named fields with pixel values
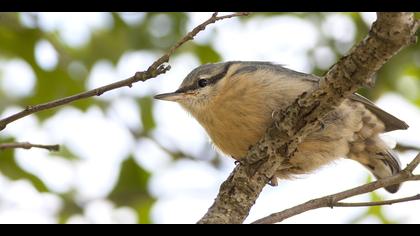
left=0, top=12, right=249, bottom=131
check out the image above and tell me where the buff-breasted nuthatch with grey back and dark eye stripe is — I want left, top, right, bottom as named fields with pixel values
left=155, top=61, right=408, bottom=193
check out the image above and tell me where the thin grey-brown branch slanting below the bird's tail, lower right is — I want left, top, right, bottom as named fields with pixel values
left=253, top=153, right=420, bottom=224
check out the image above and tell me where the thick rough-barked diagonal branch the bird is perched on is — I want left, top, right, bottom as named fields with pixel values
left=198, top=13, right=418, bottom=223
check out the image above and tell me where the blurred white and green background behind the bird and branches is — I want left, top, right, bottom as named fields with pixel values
left=0, top=12, right=420, bottom=223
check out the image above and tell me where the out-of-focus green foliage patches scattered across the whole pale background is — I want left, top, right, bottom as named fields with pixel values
left=0, top=13, right=420, bottom=223
